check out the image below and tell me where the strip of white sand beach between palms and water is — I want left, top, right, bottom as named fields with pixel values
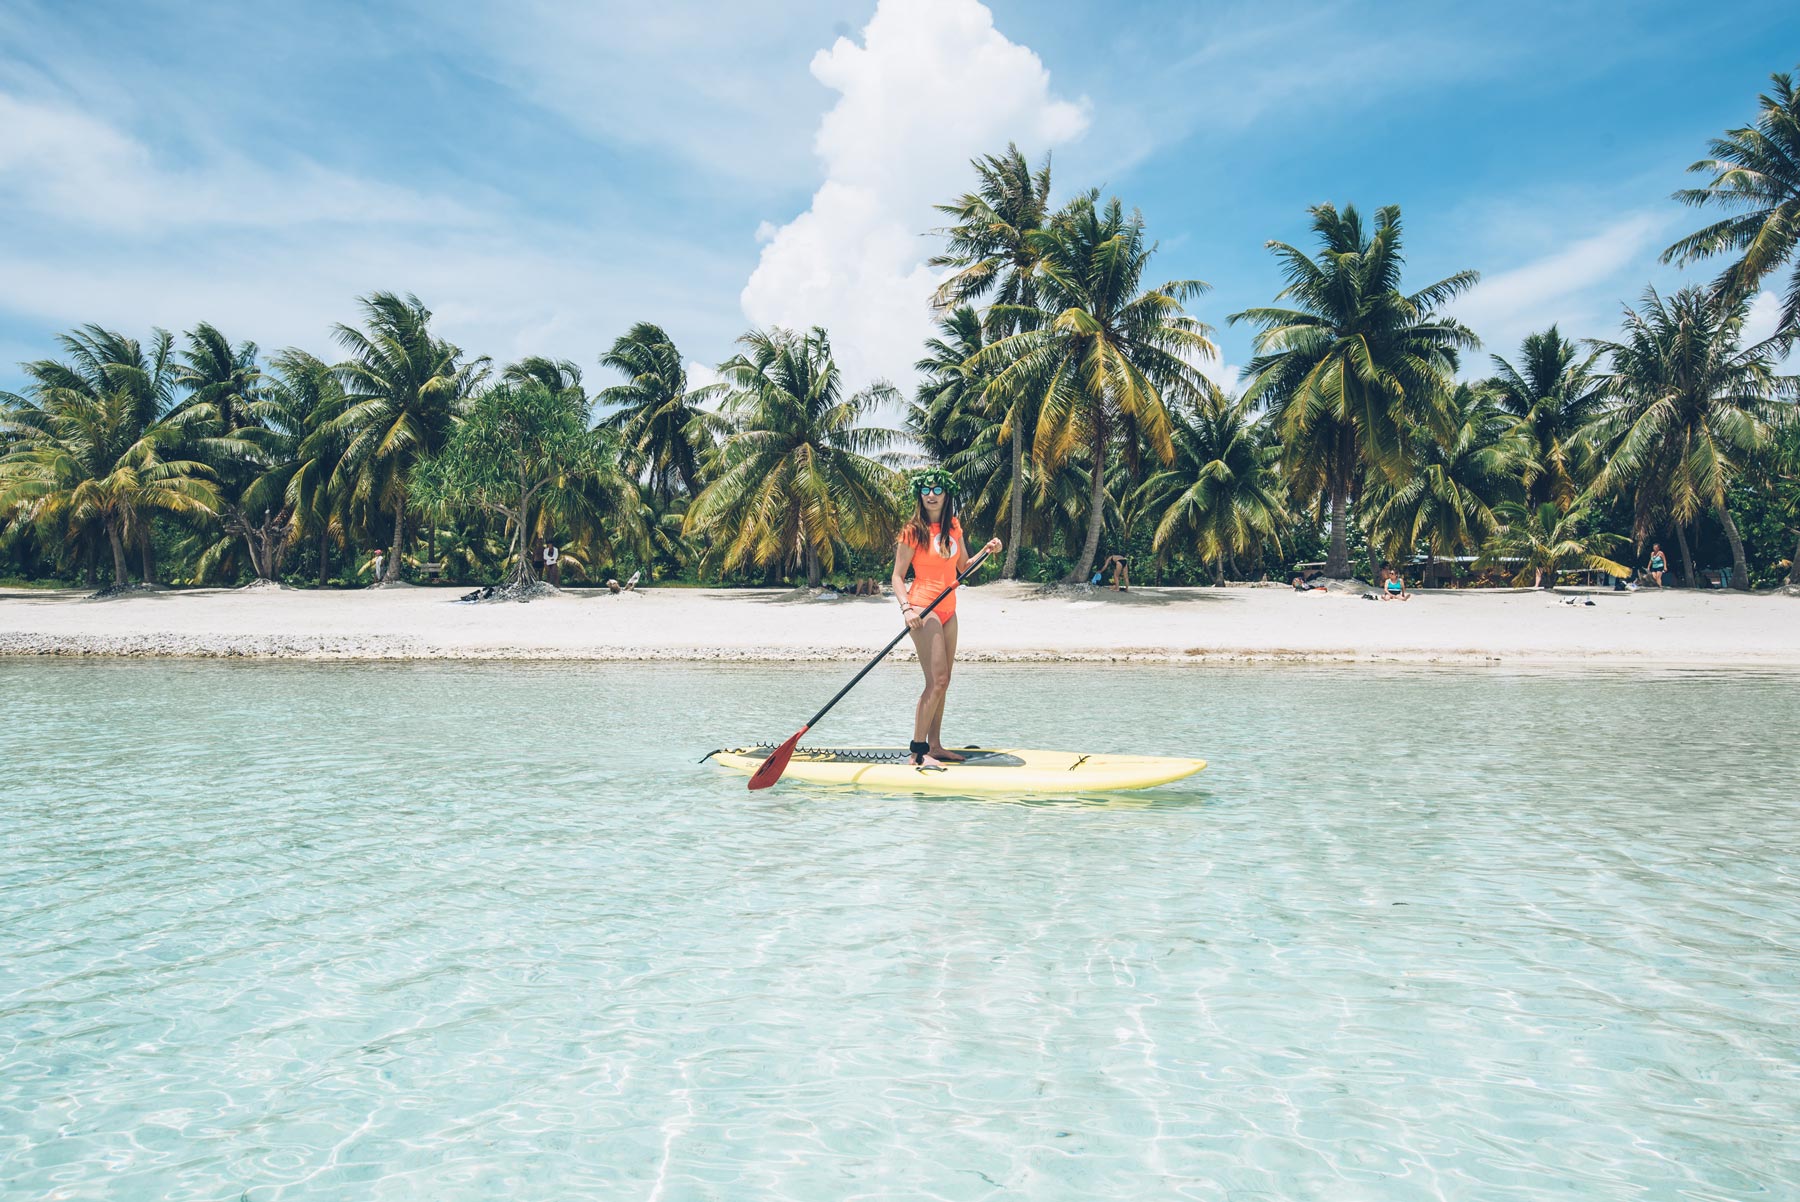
left=0, top=583, right=1800, bottom=668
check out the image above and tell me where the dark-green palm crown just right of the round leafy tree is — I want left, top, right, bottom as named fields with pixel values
left=599, top=322, right=725, bottom=507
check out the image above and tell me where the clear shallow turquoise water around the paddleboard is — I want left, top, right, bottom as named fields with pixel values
left=0, top=660, right=1800, bottom=1202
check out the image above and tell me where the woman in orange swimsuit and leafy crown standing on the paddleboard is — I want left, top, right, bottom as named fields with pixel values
left=891, top=468, right=1001, bottom=768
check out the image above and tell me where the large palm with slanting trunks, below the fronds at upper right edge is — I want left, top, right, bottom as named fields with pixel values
left=1591, top=288, right=1795, bottom=588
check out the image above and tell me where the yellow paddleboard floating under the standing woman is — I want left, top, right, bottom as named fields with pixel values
left=711, top=747, right=1206, bottom=794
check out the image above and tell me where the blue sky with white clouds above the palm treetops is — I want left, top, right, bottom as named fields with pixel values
left=0, top=0, right=1800, bottom=403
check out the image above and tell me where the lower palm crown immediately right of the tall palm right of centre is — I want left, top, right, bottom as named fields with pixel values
left=1364, top=385, right=1526, bottom=576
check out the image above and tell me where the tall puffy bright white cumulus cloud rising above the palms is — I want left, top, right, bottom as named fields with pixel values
left=740, top=0, right=1087, bottom=387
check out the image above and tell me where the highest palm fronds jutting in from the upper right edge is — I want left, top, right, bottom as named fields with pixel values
left=1663, top=72, right=1800, bottom=338
